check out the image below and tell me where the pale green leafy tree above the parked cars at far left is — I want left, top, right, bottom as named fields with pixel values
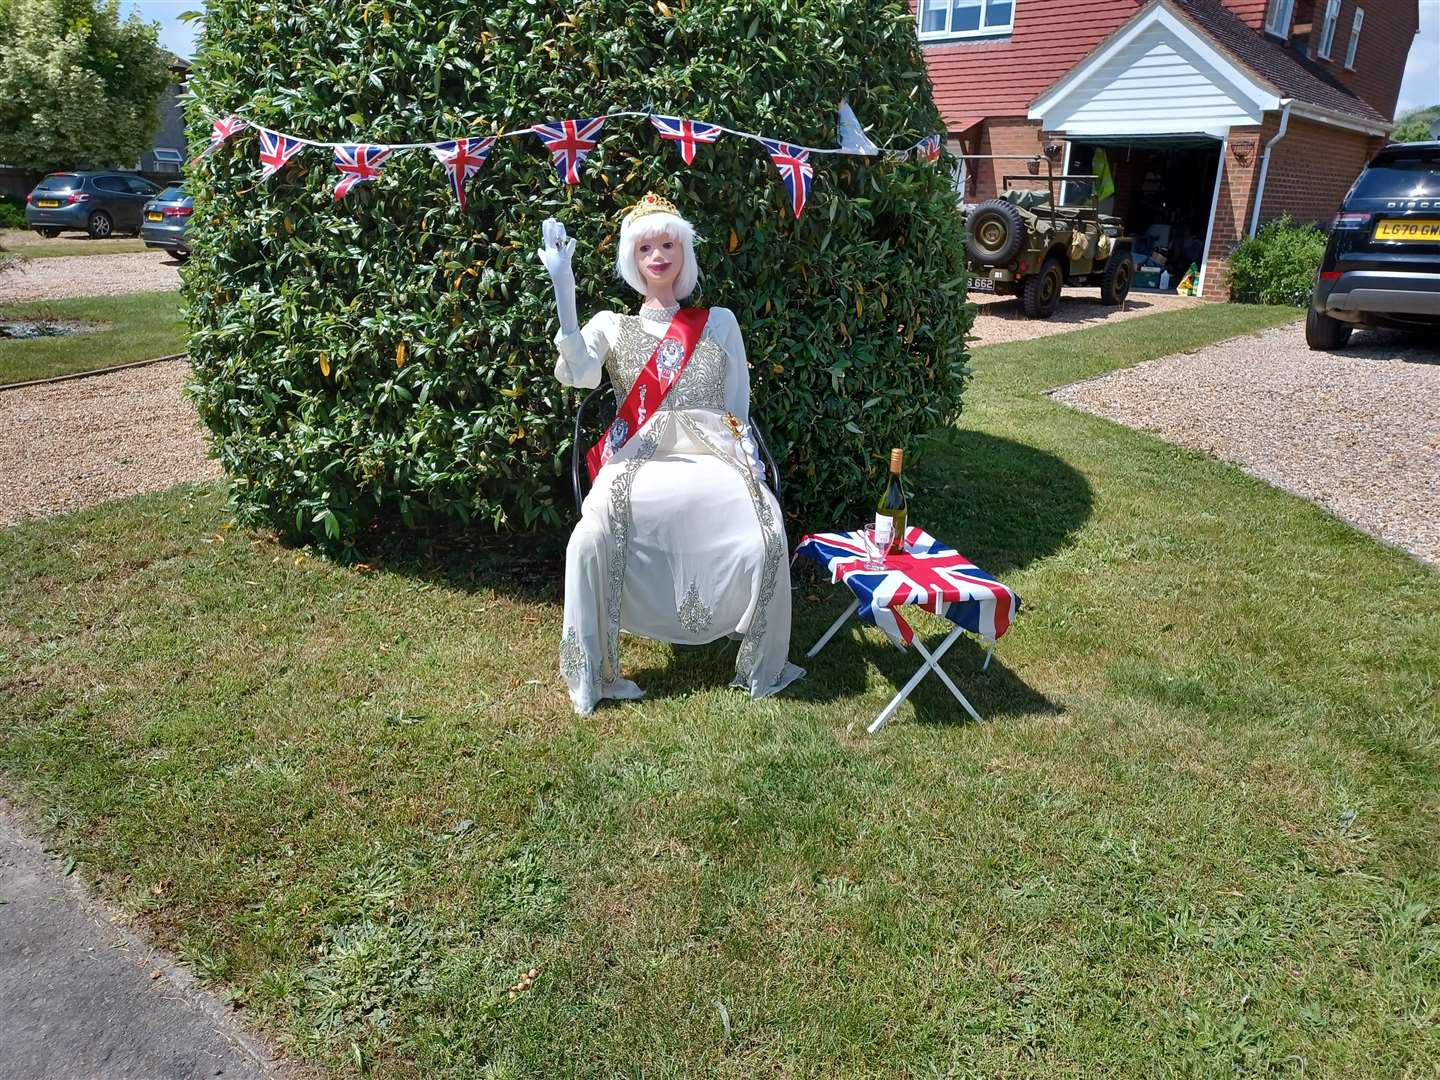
left=0, top=0, right=171, bottom=173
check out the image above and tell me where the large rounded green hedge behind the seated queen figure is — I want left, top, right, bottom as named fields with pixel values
left=186, top=0, right=969, bottom=547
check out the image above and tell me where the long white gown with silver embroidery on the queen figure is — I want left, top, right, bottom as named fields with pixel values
left=554, top=308, right=805, bottom=713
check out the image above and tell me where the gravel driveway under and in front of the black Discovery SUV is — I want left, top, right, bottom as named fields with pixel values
left=1051, top=323, right=1440, bottom=564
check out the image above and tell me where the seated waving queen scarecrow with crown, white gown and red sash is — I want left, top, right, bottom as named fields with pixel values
left=539, top=194, right=805, bottom=713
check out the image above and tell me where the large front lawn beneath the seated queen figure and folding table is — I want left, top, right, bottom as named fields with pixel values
left=0, top=305, right=1440, bottom=1079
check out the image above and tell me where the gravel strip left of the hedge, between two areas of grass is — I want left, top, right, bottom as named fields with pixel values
left=0, top=361, right=220, bottom=526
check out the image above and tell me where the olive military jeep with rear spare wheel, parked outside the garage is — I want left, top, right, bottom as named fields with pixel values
left=965, top=164, right=1135, bottom=318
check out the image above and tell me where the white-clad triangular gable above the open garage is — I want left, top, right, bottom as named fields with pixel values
left=1030, top=0, right=1282, bottom=140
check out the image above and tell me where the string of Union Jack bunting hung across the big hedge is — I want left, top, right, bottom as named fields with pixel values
left=200, top=102, right=940, bottom=219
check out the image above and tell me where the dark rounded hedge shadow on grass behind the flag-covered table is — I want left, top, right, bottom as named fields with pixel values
left=910, top=429, right=1094, bottom=580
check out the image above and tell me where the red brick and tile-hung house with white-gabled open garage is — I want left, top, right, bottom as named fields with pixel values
left=913, top=0, right=1418, bottom=298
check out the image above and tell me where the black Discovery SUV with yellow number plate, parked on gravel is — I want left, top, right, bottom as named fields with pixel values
left=1305, top=143, right=1440, bottom=348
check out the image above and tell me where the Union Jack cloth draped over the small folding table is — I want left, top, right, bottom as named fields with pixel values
left=795, top=526, right=1020, bottom=647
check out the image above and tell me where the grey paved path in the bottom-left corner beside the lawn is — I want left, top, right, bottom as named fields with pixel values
left=0, top=801, right=282, bottom=1080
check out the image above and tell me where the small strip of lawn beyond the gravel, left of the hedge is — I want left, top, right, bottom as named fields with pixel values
left=0, top=292, right=186, bottom=386
